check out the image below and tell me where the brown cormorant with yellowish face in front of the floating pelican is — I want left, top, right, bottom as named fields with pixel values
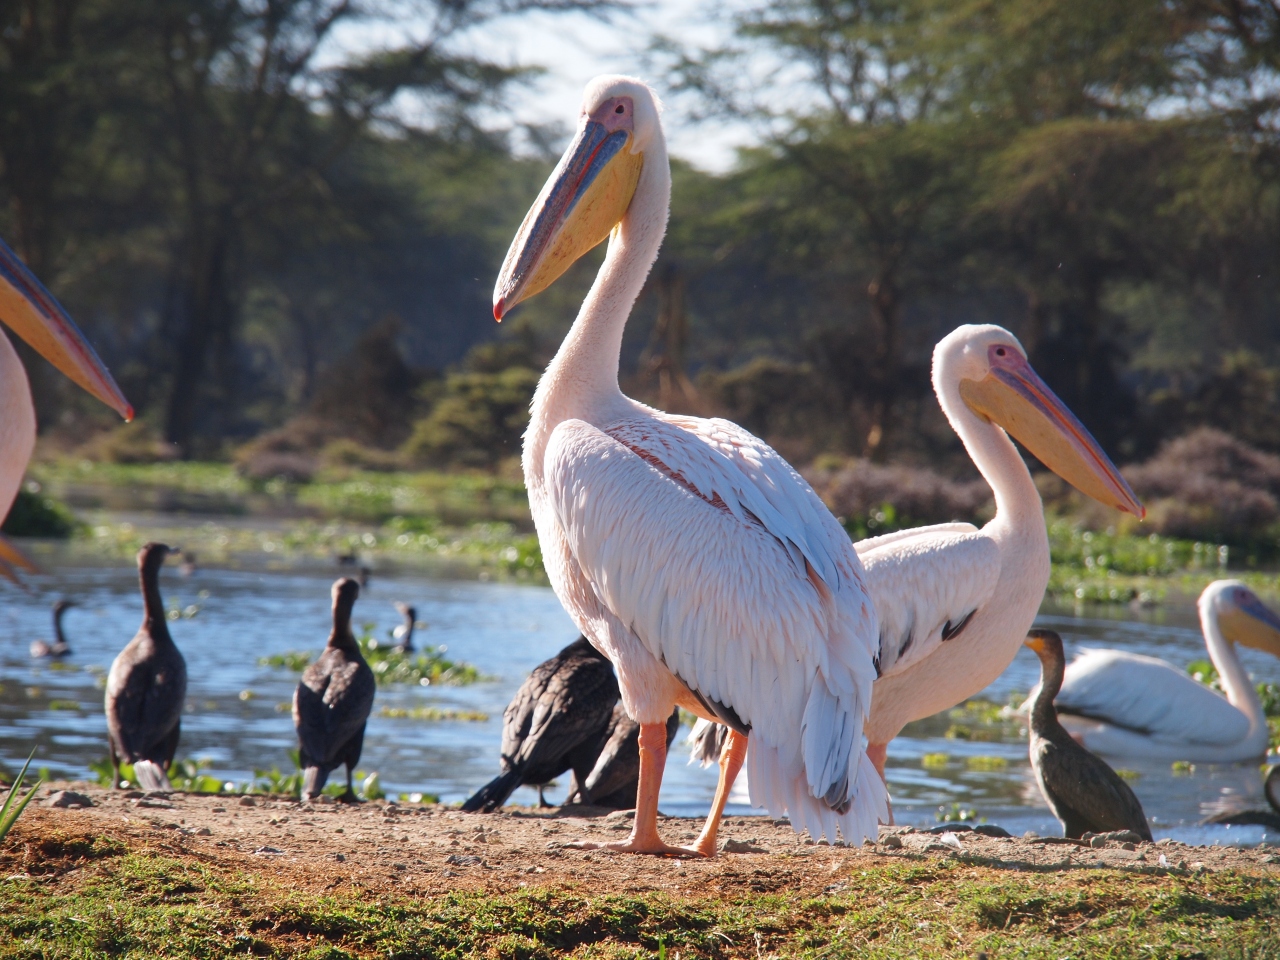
left=1025, top=630, right=1151, bottom=840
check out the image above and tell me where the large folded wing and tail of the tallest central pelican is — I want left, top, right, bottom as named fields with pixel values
left=544, top=417, right=884, bottom=837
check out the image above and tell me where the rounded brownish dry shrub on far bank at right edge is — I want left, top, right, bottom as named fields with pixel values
left=1124, top=428, right=1280, bottom=541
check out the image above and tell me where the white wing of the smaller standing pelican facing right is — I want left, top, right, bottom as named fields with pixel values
left=855, top=524, right=1000, bottom=676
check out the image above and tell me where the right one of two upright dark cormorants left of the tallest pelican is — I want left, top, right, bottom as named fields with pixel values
left=293, top=577, right=376, bottom=801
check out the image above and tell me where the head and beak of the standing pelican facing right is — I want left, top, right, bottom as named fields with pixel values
left=933, top=325, right=1147, bottom=518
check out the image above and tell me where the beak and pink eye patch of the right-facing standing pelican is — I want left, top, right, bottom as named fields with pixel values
left=960, top=344, right=1147, bottom=520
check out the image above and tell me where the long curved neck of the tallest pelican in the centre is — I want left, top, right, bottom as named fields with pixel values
left=524, top=129, right=671, bottom=488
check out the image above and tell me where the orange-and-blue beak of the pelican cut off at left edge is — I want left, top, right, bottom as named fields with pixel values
left=0, top=241, right=133, bottom=420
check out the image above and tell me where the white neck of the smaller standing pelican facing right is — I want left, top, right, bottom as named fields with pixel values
left=933, top=362, right=1048, bottom=537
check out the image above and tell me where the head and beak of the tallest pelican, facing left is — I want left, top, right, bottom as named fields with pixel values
left=493, top=77, right=660, bottom=321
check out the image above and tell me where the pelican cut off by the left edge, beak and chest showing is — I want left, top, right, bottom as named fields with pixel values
left=0, top=241, right=133, bottom=580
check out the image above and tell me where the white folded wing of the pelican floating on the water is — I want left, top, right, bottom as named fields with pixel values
left=1053, top=650, right=1249, bottom=746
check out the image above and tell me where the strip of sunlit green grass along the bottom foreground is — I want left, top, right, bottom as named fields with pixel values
left=0, top=837, right=1280, bottom=960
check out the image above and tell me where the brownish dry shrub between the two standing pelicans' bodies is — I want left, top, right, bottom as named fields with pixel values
left=804, top=460, right=991, bottom=524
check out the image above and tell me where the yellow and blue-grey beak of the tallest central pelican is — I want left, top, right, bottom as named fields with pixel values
left=493, top=119, right=644, bottom=323
